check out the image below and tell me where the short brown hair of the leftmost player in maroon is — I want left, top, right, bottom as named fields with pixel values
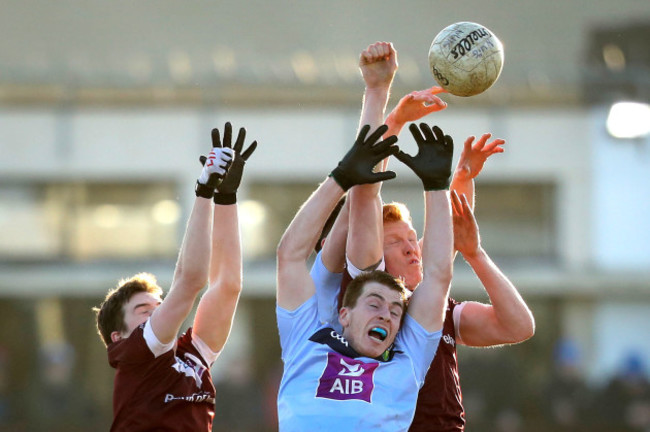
left=93, top=273, right=162, bottom=346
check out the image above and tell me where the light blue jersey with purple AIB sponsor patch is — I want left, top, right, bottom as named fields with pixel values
left=276, top=296, right=441, bottom=432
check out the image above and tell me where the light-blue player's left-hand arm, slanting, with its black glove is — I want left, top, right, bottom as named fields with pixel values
left=277, top=126, right=398, bottom=310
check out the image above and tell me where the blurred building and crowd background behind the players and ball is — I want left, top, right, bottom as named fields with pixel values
left=0, top=0, right=650, bottom=431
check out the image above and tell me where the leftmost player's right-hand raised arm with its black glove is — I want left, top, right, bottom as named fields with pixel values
left=194, top=123, right=257, bottom=352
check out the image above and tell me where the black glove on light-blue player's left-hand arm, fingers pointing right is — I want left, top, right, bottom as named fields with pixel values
left=330, top=125, right=399, bottom=191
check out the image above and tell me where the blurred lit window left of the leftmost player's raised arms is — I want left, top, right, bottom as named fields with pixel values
left=0, top=182, right=181, bottom=261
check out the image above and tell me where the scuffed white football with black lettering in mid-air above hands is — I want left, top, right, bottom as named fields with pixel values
left=429, top=22, right=503, bottom=96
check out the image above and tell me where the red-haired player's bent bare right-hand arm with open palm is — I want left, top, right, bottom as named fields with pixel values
left=453, top=196, right=535, bottom=346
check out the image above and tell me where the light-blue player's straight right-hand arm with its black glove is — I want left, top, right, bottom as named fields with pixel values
left=396, top=123, right=454, bottom=332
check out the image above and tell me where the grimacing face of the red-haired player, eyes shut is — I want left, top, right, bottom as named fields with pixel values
left=384, top=220, right=422, bottom=291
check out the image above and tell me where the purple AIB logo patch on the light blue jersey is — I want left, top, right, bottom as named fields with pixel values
left=316, top=352, right=379, bottom=402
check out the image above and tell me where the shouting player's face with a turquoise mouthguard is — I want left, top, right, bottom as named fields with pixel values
left=339, top=282, right=404, bottom=358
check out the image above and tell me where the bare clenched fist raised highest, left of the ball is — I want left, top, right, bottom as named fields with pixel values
left=359, top=42, right=398, bottom=89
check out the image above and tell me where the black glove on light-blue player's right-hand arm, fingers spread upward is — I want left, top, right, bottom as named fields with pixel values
left=395, top=123, right=454, bottom=191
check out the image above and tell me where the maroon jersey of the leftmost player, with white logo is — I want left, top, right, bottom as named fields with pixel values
left=108, top=324, right=215, bottom=432
